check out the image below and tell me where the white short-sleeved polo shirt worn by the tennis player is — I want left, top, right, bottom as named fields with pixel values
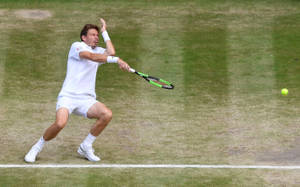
left=58, top=42, right=105, bottom=98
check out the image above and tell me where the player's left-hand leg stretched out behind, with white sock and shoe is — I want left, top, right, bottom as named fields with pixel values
left=25, top=108, right=69, bottom=162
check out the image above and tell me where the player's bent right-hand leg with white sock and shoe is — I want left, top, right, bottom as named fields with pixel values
left=77, top=102, right=112, bottom=162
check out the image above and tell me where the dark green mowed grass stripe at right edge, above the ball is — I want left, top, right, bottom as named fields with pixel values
left=272, top=13, right=300, bottom=95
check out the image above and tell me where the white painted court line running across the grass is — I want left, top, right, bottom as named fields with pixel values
left=0, top=164, right=300, bottom=170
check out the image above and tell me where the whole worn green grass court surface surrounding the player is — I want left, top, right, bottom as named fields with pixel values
left=0, top=0, right=300, bottom=186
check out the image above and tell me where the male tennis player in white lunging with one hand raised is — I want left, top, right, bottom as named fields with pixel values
left=25, top=18, right=130, bottom=163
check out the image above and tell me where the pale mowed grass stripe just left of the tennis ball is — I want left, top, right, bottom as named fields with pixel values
left=228, top=12, right=280, bottom=163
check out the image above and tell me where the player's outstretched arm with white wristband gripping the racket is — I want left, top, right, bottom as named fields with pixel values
left=79, top=51, right=130, bottom=71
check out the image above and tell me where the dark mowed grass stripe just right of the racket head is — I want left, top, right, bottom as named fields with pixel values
left=182, top=11, right=228, bottom=163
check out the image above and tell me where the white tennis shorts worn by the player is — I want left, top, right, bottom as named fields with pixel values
left=56, top=96, right=98, bottom=118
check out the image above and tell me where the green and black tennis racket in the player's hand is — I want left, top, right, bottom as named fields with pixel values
left=129, top=68, right=174, bottom=89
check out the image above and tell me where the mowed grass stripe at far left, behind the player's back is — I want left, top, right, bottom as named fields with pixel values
left=0, top=20, right=54, bottom=162
